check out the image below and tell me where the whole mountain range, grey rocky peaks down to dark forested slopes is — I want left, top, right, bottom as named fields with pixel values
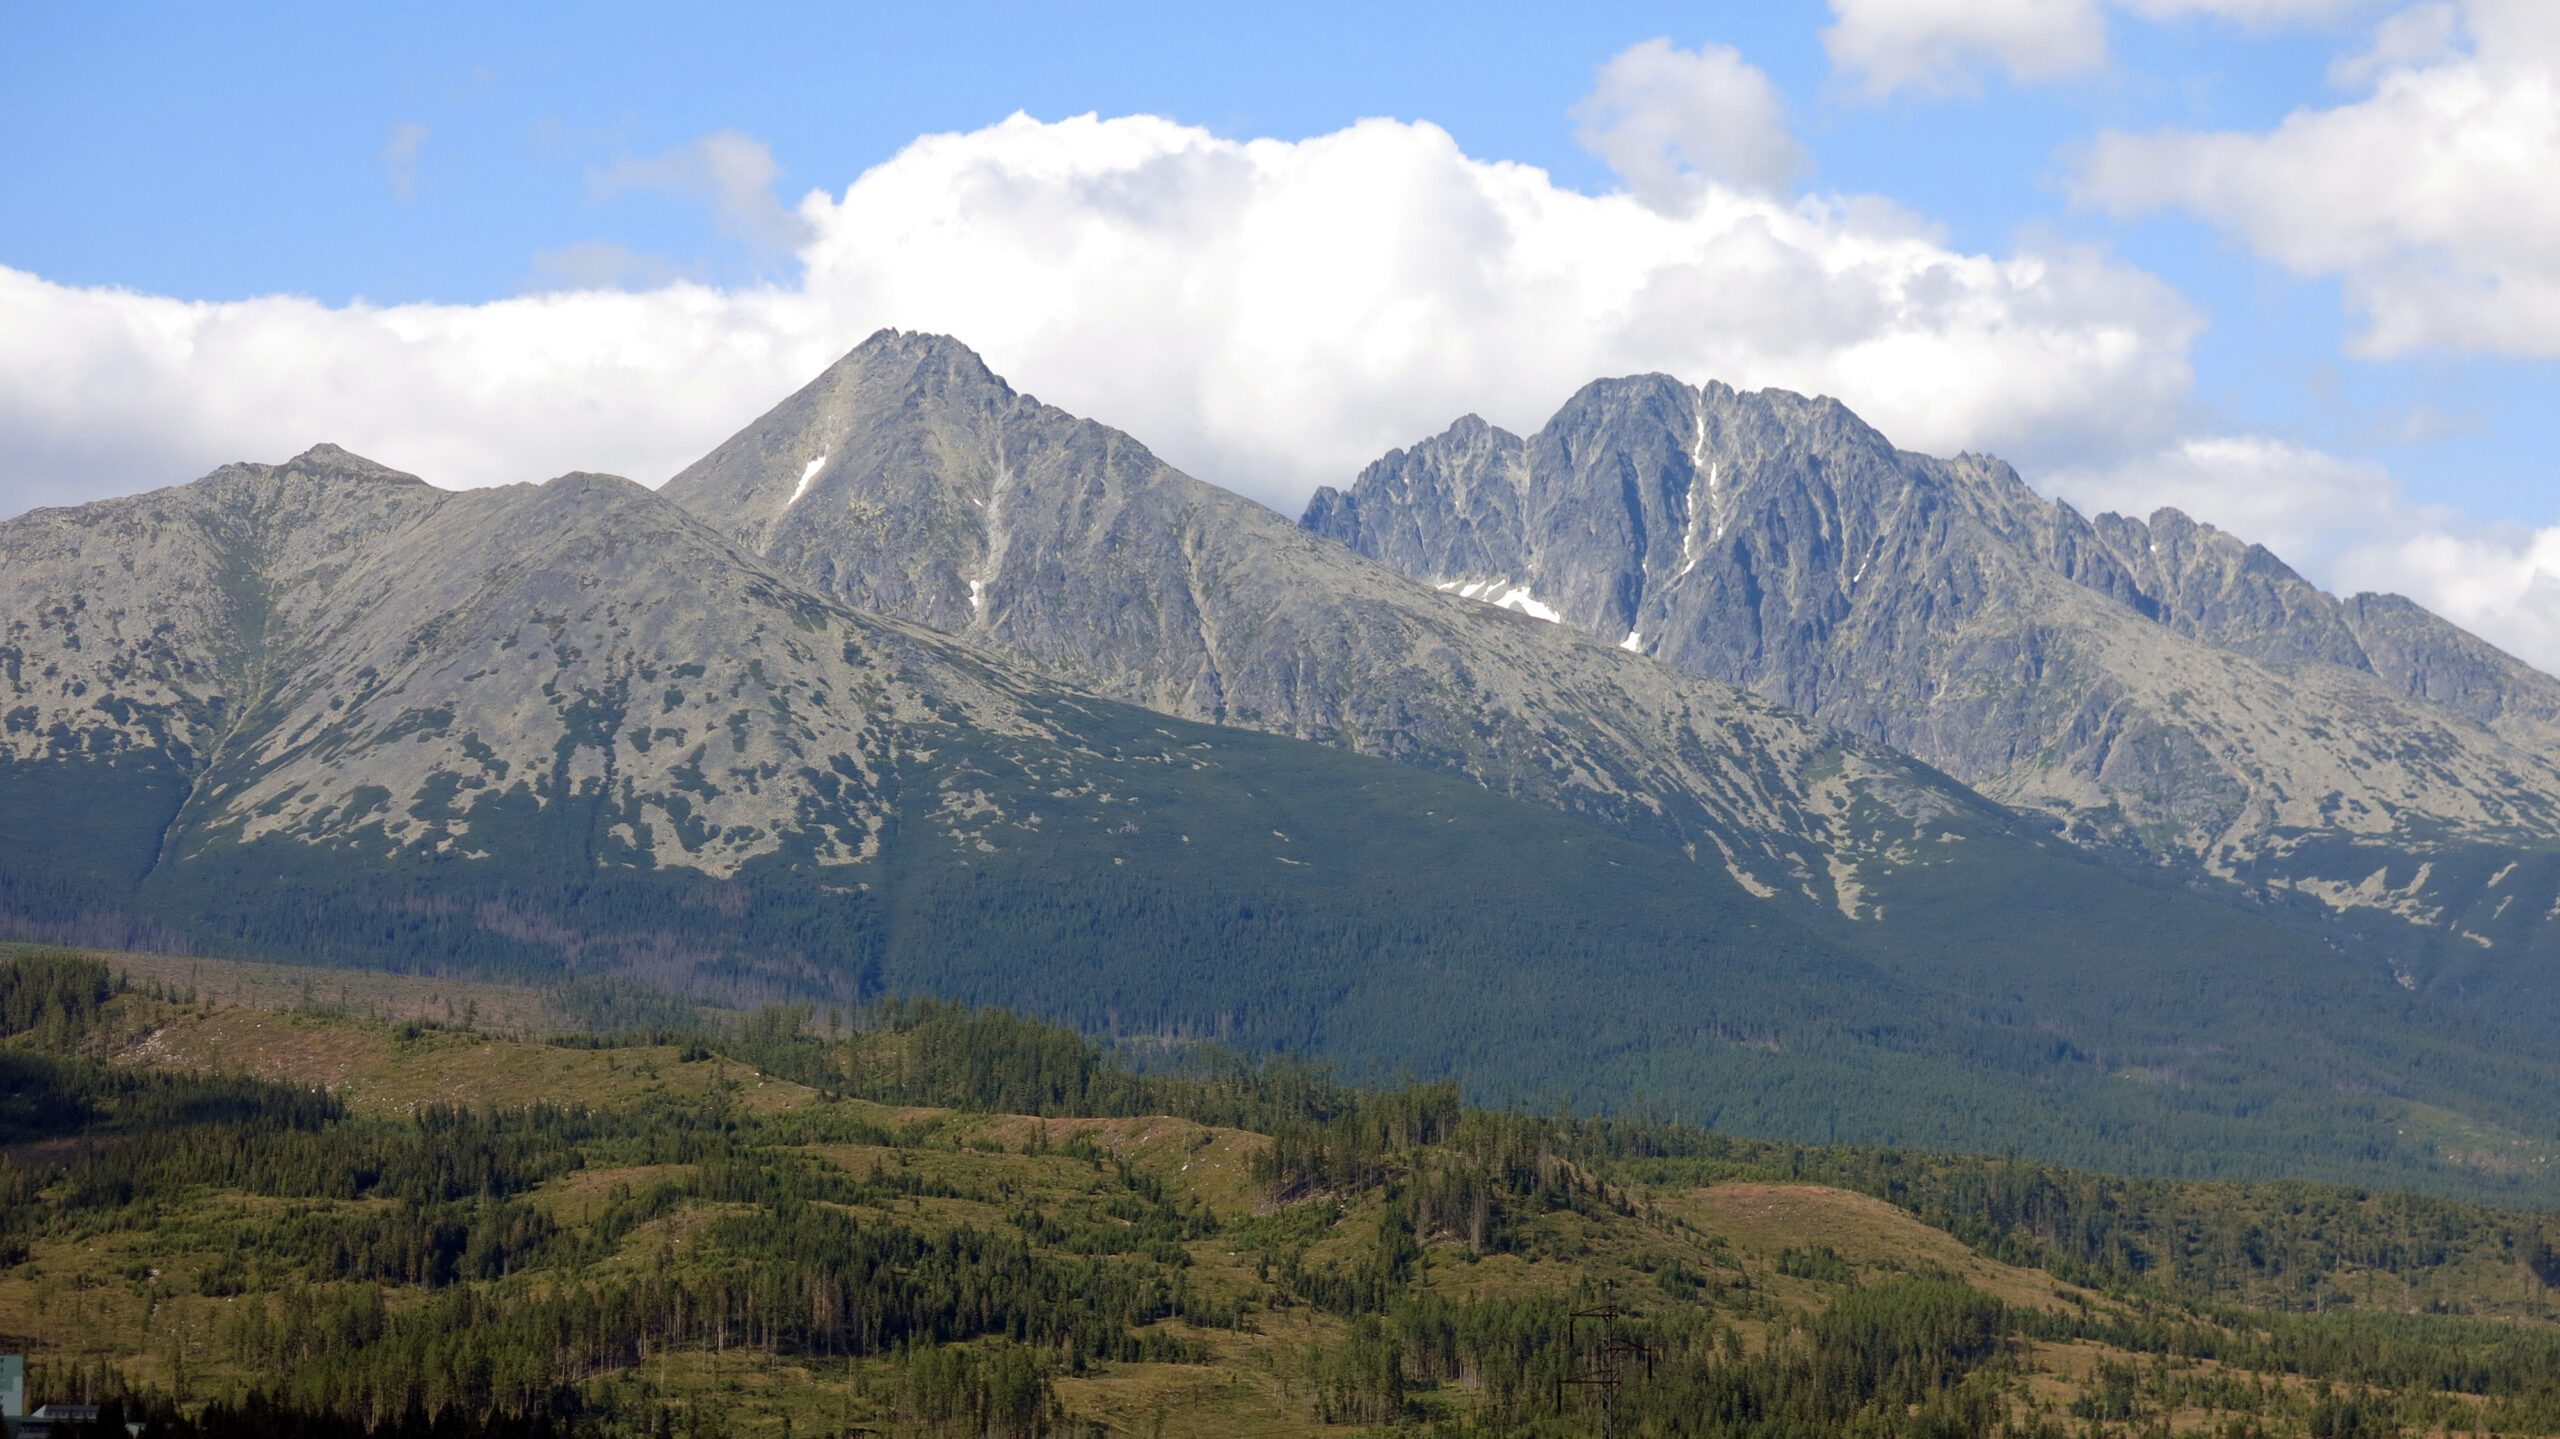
left=0, top=333, right=2560, bottom=1193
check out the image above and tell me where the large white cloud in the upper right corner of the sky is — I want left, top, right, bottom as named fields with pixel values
left=2076, top=0, right=2560, bottom=356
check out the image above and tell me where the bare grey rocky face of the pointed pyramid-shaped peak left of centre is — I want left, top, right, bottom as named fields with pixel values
left=663, top=333, right=2068, bottom=917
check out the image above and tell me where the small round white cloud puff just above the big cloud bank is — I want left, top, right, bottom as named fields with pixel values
left=1574, top=38, right=1807, bottom=210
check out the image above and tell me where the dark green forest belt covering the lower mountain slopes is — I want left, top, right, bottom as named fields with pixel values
left=0, top=675, right=2560, bottom=1203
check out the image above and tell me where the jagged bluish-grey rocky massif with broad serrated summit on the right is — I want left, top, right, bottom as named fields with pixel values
left=1303, top=376, right=2560, bottom=962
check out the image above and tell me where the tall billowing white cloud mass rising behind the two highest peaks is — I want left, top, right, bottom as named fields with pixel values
left=804, top=118, right=2196, bottom=507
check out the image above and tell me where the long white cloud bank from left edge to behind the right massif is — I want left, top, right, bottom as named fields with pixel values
left=0, top=115, right=2196, bottom=515
